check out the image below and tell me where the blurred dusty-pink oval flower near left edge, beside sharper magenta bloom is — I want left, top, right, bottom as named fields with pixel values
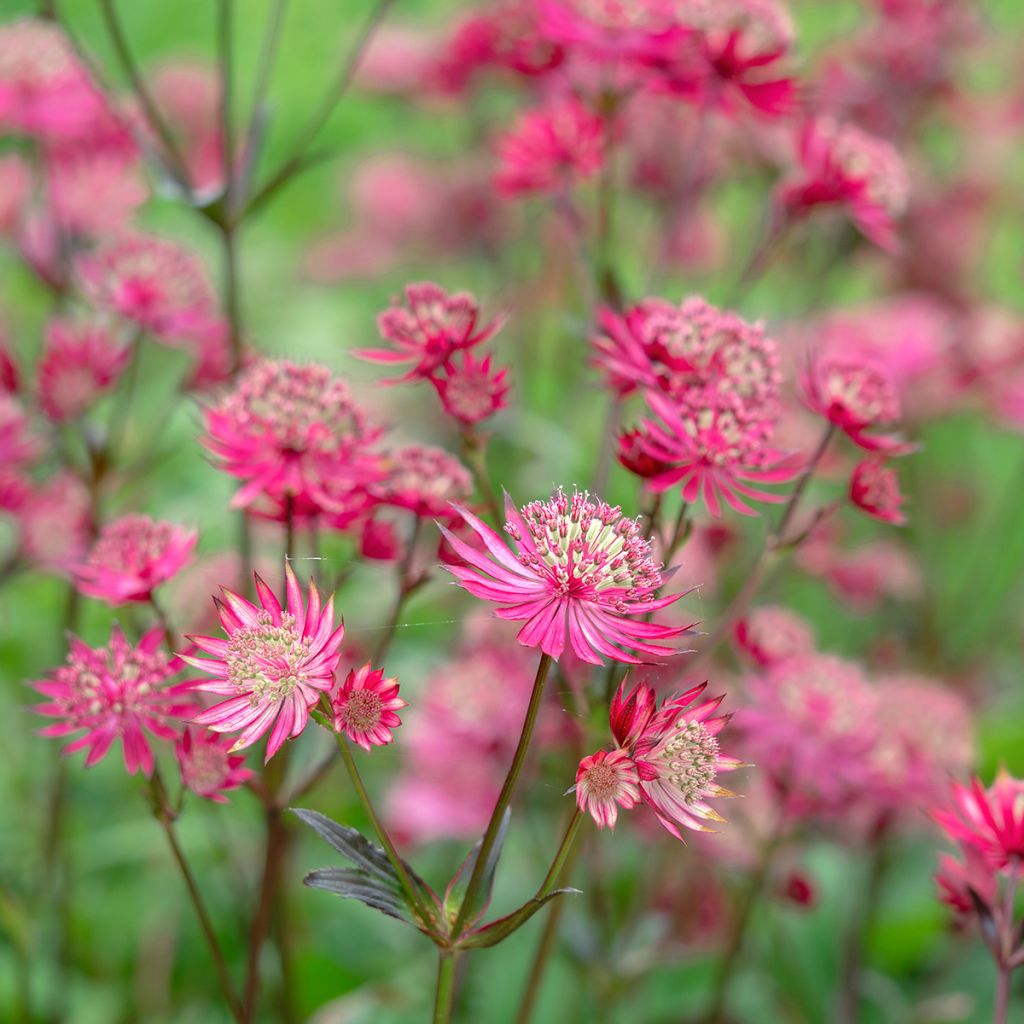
left=17, top=470, right=92, bottom=575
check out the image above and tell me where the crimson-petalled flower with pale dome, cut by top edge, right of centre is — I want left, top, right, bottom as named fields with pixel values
left=644, top=0, right=797, bottom=118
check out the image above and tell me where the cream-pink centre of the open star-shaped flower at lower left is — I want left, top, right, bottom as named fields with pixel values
left=226, top=611, right=309, bottom=705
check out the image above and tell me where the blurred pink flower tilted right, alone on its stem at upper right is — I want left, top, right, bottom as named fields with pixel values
left=780, top=118, right=909, bottom=250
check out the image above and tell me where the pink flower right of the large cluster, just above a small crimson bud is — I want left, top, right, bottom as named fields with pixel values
left=800, top=355, right=913, bottom=455
